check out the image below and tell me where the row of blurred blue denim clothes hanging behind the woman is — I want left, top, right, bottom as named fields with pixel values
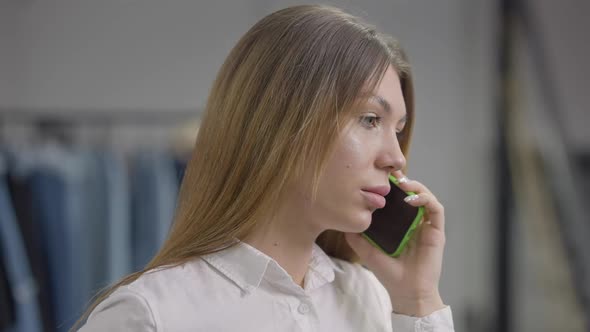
left=0, top=143, right=184, bottom=332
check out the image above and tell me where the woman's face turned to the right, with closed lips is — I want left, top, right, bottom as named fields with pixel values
left=294, top=66, right=406, bottom=233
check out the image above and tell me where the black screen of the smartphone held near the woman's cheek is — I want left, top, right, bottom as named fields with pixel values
left=364, top=180, right=418, bottom=254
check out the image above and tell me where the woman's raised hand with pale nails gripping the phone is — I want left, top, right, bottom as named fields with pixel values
left=346, top=171, right=445, bottom=317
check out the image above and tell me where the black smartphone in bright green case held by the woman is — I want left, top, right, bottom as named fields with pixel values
left=362, top=175, right=424, bottom=257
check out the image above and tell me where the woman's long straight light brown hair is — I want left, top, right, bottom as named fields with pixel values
left=74, top=5, right=414, bottom=327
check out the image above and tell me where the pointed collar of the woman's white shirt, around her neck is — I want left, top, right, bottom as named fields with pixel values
left=202, top=241, right=344, bottom=293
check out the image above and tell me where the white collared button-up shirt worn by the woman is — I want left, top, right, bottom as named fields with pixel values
left=80, top=242, right=454, bottom=332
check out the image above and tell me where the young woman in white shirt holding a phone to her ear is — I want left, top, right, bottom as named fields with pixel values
left=81, top=6, right=453, bottom=332
